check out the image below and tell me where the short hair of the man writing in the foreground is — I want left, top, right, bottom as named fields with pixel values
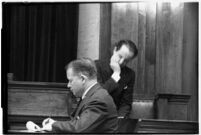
left=65, top=58, right=97, bottom=79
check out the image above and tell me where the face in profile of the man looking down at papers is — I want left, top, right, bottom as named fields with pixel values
left=66, top=68, right=84, bottom=97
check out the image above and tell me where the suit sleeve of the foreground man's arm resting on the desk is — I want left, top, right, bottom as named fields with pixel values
left=52, top=101, right=107, bottom=133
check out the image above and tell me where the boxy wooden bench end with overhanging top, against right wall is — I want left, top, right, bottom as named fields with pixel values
left=155, top=93, right=190, bottom=120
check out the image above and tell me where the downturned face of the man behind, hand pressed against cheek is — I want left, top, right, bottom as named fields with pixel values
left=111, top=45, right=134, bottom=67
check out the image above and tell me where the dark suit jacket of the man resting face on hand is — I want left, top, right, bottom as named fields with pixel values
left=95, top=60, right=135, bottom=117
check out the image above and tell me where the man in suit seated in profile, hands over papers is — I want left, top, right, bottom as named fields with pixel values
left=42, top=59, right=118, bottom=133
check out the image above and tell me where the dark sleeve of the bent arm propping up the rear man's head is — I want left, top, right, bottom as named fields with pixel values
left=95, top=61, right=119, bottom=93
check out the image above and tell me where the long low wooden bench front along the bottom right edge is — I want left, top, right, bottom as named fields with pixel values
left=135, top=119, right=198, bottom=134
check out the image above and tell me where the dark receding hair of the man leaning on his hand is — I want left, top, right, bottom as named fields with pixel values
left=115, top=40, right=138, bottom=58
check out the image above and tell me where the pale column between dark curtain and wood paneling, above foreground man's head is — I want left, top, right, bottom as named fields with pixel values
left=77, top=4, right=100, bottom=60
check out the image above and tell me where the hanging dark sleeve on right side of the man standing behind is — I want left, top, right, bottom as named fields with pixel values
left=118, top=71, right=135, bottom=117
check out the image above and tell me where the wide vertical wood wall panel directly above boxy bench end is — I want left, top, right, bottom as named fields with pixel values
left=156, top=3, right=183, bottom=93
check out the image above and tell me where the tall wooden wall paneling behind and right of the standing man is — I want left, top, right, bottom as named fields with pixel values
left=100, top=2, right=198, bottom=120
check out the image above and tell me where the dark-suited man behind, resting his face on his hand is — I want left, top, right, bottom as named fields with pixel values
left=95, top=40, right=138, bottom=118
